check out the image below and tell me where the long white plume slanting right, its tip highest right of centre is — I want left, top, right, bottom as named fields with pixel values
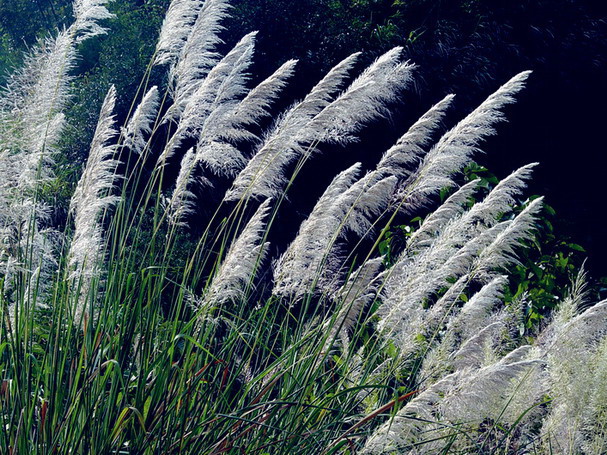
left=225, top=48, right=413, bottom=200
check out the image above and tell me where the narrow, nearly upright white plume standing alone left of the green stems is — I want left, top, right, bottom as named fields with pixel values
left=68, top=86, right=119, bottom=321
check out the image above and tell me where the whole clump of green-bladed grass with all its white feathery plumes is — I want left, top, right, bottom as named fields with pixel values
left=0, top=0, right=607, bottom=454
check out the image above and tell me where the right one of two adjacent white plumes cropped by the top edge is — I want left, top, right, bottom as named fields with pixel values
left=169, top=0, right=230, bottom=116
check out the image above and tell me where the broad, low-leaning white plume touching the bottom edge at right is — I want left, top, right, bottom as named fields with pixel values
left=361, top=346, right=542, bottom=454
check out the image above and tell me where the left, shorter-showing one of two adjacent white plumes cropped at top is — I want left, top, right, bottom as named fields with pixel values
left=154, top=0, right=207, bottom=65
